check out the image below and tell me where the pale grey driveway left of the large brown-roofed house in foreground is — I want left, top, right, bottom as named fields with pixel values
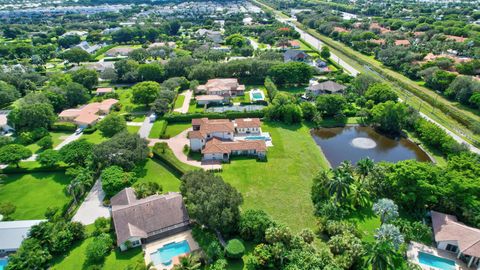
left=72, top=179, right=111, bottom=225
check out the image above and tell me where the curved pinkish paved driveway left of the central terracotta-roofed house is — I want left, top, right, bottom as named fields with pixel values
left=149, top=128, right=222, bottom=170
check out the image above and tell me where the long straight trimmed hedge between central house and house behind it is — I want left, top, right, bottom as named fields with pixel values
left=163, top=111, right=265, bottom=123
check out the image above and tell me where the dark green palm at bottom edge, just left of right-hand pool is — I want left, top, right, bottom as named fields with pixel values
left=365, top=241, right=398, bottom=270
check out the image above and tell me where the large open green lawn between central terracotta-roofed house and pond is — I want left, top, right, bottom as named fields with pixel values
left=221, top=123, right=328, bottom=232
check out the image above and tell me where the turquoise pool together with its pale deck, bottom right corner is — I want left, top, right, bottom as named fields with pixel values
left=407, top=241, right=472, bottom=270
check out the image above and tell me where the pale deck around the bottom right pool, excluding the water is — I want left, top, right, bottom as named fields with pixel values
left=407, top=241, right=473, bottom=270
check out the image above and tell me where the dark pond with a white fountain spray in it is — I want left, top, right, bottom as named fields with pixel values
left=311, top=126, right=431, bottom=167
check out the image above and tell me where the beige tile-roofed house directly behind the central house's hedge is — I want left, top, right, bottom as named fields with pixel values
left=195, top=78, right=245, bottom=105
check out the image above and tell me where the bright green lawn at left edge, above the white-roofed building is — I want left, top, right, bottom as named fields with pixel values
left=0, top=172, right=70, bottom=220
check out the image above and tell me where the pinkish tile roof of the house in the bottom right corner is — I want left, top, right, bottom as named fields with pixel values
left=431, top=211, right=480, bottom=257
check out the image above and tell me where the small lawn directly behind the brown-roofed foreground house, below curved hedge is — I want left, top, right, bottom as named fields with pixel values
left=135, top=159, right=180, bottom=192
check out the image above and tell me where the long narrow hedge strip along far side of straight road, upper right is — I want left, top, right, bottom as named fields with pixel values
left=302, top=24, right=478, bottom=142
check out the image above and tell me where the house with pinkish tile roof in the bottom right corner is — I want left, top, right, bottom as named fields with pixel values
left=430, top=211, right=480, bottom=269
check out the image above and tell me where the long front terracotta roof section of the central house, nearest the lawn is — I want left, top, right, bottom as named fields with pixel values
left=202, top=138, right=267, bottom=154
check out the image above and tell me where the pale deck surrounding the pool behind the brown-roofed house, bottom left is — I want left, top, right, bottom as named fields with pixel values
left=143, top=230, right=200, bottom=270
